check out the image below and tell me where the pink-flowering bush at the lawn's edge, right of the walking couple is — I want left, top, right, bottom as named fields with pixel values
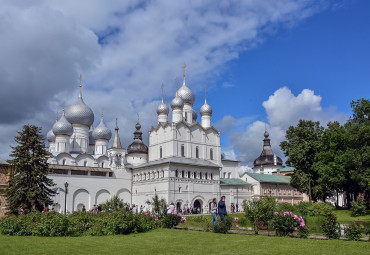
left=271, top=211, right=308, bottom=237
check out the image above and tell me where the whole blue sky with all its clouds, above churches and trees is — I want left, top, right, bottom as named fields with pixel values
left=0, top=0, right=370, bottom=166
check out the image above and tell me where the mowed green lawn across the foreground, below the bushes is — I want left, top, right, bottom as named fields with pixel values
left=0, top=229, right=370, bottom=255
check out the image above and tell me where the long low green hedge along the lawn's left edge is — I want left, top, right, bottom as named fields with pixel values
left=0, top=211, right=158, bottom=236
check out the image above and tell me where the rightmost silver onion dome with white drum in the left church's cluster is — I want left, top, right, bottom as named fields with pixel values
left=92, top=114, right=112, bottom=156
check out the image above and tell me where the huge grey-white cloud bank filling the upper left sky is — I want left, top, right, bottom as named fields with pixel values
left=0, top=0, right=325, bottom=157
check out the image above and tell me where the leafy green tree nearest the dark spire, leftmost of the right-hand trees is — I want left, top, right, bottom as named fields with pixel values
left=280, top=120, right=324, bottom=201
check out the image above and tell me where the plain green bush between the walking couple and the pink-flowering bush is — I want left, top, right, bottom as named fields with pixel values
left=243, top=197, right=276, bottom=234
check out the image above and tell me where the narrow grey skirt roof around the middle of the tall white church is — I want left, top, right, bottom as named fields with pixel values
left=132, top=157, right=221, bottom=169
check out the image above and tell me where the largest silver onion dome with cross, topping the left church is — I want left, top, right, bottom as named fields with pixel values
left=66, top=84, right=94, bottom=127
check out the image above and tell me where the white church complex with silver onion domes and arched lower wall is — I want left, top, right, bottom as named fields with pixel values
left=47, top=66, right=253, bottom=213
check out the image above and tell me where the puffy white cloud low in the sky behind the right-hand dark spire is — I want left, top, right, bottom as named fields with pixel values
left=230, top=87, right=348, bottom=167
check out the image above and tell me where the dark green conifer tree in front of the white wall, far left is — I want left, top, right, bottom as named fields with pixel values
left=5, top=125, right=55, bottom=214
